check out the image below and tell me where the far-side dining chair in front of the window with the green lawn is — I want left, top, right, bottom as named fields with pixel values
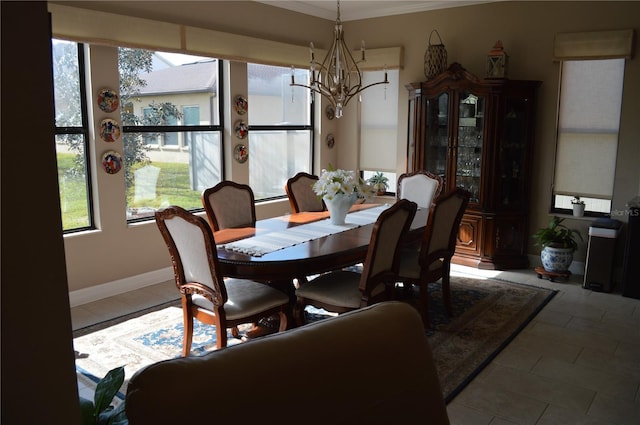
left=202, top=180, right=256, bottom=232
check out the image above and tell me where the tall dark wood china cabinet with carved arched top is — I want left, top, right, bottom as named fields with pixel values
left=407, top=63, right=540, bottom=269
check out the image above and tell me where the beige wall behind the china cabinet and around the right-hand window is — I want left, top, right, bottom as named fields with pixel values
left=340, top=1, right=640, bottom=261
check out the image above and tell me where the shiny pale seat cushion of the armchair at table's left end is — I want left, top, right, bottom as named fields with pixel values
left=192, top=279, right=289, bottom=320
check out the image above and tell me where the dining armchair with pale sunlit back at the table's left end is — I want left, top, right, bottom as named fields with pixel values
left=155, top=206, right=290, bottom=356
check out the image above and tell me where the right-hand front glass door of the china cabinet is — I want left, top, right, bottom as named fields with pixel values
left=456, top=92, right=485, bottom=202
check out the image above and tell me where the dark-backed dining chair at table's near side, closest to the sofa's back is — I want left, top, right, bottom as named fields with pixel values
left=294, top=199, right=417, bottom=325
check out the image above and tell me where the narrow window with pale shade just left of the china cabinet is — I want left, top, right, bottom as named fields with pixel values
left=360, top=70, right=400, bottom=192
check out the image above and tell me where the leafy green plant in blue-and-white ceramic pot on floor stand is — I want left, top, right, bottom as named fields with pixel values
left=533, top=216, right=582, bottom=273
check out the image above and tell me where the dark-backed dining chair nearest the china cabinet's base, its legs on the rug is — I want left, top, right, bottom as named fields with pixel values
left=397, top=187, right=471, bottom=329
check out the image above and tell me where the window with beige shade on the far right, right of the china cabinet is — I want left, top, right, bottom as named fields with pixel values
left=553, top=59, right=625, bottom=216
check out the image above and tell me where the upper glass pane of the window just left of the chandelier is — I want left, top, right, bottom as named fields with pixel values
left=247, top=63, right=311, bottom=126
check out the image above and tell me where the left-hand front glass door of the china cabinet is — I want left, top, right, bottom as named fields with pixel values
left=424, top=93, right=449, bottom=188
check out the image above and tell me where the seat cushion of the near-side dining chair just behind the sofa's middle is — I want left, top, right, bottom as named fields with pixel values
left=296, top=270, right=385, bottom=309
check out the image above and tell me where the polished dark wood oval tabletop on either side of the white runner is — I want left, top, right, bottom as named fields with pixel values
left=214, top=204, right=429, bottom=281
